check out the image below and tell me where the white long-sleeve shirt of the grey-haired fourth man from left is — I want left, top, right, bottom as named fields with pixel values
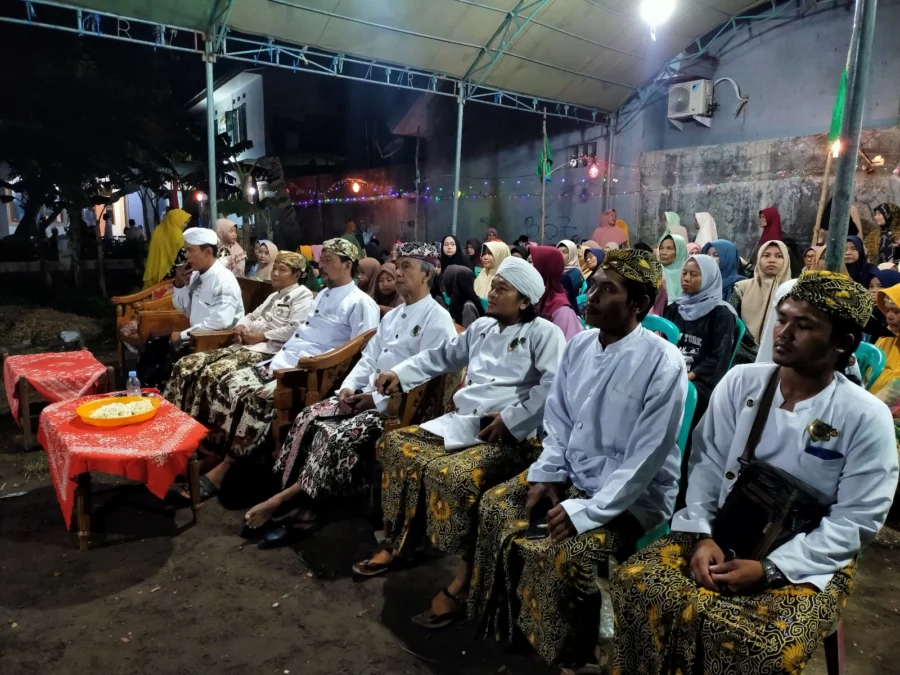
left=341, top=295, right=456, bottom=413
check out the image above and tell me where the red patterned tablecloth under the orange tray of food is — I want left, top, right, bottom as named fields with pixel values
left=38, top=394, right=207, bottom=527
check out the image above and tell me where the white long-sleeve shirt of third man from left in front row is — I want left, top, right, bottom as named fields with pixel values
left=269, top=282, right=381, bottom=375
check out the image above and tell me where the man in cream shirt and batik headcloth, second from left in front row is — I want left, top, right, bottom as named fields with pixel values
left=165, top=251, right=313, bottom=424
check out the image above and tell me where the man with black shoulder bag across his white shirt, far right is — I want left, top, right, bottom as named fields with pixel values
left=611, top=272, right=897, bottom=675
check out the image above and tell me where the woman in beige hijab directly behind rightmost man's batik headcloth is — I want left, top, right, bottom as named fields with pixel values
left=731, top=241, right=791, bottom=364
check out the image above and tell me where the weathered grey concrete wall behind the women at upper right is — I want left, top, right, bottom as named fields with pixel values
left=611, top=0, right=900, bottom=253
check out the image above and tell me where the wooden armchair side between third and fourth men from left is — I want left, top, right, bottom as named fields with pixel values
left=272, top=328, right=376, bottom=448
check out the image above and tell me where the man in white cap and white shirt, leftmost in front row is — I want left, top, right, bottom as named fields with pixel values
left=138, top=227, right=244, bottom=389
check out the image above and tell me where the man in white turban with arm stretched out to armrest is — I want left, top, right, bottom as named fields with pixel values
left=353, top=258, right=565, bottom=628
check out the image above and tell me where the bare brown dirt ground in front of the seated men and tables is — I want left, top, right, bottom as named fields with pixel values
left=0, top=402, right=900, bottom=675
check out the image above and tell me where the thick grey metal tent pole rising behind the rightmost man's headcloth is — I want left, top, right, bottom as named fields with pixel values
left=825, top=0, right=878, bottom=272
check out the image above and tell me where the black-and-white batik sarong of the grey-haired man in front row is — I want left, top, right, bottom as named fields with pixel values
left=274, top=396, right=384, bottom=499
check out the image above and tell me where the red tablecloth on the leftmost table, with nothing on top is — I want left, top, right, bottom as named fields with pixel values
left=3, top=350, right=106, bottom=424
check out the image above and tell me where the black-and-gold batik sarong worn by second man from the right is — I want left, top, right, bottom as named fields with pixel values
left=468, top=472, right=640, bottom=666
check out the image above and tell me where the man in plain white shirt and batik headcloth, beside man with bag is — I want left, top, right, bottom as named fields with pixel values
left=469, top=249, right=688, bottom=666
